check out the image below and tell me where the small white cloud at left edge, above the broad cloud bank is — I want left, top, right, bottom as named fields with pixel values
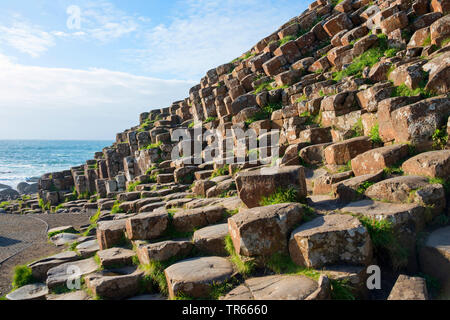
left=0, top=17, right=55, bottom=58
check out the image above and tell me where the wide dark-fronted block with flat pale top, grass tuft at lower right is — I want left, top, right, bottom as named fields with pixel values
left=236, top=166, right=307, bottom=208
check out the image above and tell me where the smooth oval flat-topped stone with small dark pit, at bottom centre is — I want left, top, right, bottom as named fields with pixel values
left=164, top=257, right=233, bottom=299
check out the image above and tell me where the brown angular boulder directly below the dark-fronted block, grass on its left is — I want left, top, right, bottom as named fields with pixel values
left=228, top=203, right=303, bottom=258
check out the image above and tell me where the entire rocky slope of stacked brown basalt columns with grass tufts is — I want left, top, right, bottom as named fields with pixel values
left=3, top=0, right=450, bottom=300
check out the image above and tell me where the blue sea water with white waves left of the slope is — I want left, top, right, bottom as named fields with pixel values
left=0, top=140, right=112, bottom=188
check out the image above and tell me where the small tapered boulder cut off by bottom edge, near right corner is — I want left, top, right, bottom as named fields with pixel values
left=388, top=274, right=428, bottom=300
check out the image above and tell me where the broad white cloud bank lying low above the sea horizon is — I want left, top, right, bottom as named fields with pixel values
left=0, top=55, right=194, bottom=139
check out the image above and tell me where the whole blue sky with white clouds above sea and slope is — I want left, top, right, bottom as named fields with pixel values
left=0, top=0, right=309, bottom=140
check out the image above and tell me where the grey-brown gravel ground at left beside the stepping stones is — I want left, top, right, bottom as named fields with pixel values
left=0, top=214, right=91, bottom=296
